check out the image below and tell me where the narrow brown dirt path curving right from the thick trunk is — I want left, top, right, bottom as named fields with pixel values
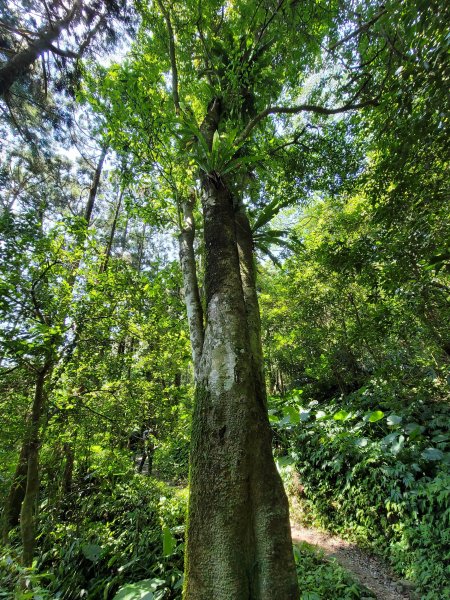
left=292, top=523, right=417, bottom=600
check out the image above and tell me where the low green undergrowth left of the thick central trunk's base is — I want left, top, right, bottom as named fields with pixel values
left=0, top=472, right=187, bottom=600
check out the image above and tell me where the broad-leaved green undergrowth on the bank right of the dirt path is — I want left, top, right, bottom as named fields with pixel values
left=271, top=382, right=450, bottom=600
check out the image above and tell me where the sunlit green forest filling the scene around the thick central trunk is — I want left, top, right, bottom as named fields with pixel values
left=0, top=0, right=450, bottom=600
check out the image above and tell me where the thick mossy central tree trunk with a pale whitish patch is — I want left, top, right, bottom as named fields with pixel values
left=185, top=176, right=298, bottom=600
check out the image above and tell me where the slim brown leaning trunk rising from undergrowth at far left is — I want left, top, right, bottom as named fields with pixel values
left=20, top=363, right=51, bottom=567
